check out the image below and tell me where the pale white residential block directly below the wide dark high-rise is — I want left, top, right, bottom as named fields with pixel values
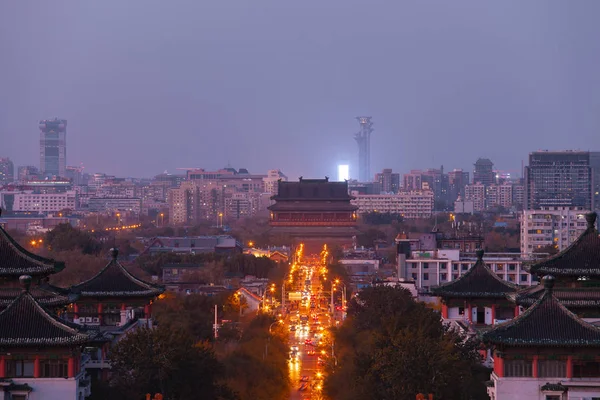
left=520, top=207, right=589, bottom=254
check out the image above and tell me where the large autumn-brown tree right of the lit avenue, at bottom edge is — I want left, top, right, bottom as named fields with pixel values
left=324, top=286, right=485, bottom=400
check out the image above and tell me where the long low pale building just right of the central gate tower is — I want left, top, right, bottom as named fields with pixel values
left=350, top=190, right=434, bottom=219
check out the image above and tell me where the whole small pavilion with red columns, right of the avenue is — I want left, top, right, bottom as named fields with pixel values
left=431, top=250, right=518, bottom=325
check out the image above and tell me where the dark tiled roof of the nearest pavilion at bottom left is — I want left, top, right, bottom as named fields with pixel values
left=0, top=275, right=90, bottom=347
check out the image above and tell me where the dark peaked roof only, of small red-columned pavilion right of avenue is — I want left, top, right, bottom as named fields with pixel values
left=431, top=250, right=517, bottom=299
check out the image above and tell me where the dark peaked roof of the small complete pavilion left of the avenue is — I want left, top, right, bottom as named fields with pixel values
left=71, top=249, right=164, bottom=297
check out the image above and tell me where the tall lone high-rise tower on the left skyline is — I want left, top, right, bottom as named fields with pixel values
left=39, top=118, right=67, bottom=178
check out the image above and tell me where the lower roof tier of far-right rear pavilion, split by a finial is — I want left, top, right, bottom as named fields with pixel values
left=510, top=285, right=600, bottom=308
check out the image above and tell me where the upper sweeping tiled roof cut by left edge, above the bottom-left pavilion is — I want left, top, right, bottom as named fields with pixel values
left=0, top=226, right=65, bottom=276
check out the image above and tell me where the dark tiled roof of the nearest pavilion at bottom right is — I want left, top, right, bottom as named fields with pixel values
left=482, top=276, right=600, bottom=347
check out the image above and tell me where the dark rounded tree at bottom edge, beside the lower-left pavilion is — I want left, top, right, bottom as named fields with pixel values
left=110, top=326, right=223, bottom=400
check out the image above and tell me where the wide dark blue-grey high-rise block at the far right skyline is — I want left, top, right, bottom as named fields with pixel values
left=524, top=151, right=600, bottom=210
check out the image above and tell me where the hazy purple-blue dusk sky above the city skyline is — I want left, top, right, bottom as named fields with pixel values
left=0, top=0, right=600, bottom=179
